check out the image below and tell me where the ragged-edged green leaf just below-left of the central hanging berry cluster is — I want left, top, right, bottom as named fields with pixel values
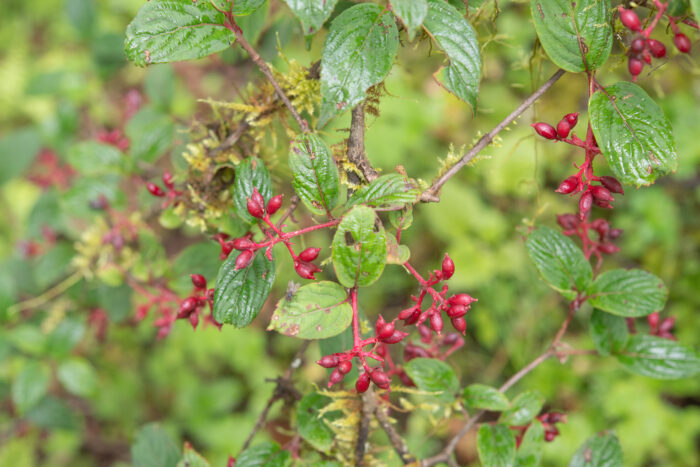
left=297, top=392, right=341, bottom=452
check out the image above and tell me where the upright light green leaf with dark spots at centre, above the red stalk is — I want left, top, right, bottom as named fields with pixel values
left=332, top=206, right=387, bottom=288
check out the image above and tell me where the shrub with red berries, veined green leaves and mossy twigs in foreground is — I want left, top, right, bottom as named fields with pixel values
left=5, top=0, right=700, bottom=467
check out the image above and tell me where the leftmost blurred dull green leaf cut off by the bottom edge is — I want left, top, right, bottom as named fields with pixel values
left=131, top=423, right=181, bottom=467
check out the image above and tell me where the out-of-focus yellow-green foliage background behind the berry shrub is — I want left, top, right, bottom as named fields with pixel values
left=0, top=0, right=700, bottom=467
